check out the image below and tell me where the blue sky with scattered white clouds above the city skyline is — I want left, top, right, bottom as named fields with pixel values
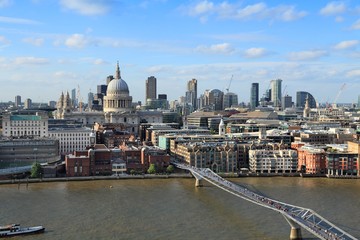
left=0, top=0, right=360, bottom=103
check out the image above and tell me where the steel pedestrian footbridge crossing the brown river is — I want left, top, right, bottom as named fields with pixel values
left=172, top=161, right=357, bottom=240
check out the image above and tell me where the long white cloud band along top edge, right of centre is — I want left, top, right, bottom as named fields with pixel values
left=187, top=1, right=307, bottom=21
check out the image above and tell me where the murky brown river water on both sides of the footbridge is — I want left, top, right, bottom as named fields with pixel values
left=0, top=177, right=360, bottom=240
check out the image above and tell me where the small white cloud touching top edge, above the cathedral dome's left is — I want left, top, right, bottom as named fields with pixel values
left=60, top=0, right=110, bottom=15
